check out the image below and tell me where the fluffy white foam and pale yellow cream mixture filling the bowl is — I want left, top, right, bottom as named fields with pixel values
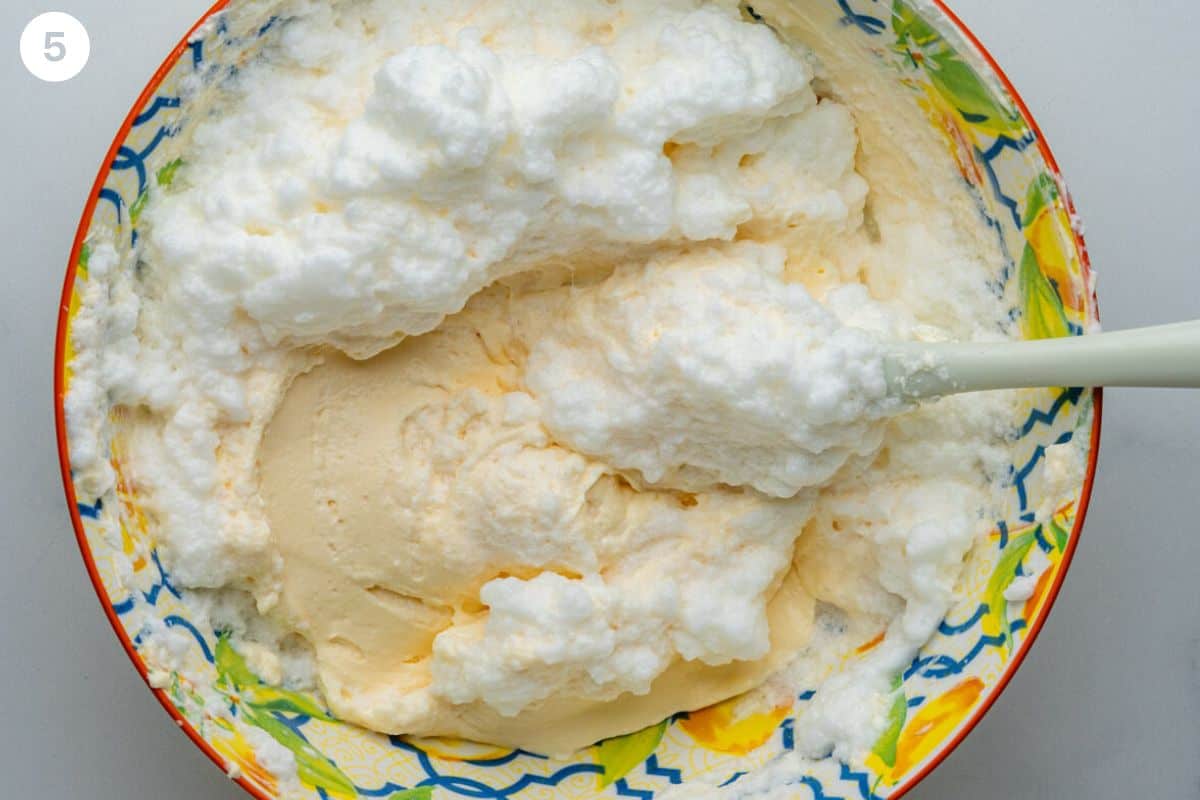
left=67, top=0, right=1084, bottom=777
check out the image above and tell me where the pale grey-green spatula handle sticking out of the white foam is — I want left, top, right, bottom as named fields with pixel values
left=887, top=321, right=1200, bottom=399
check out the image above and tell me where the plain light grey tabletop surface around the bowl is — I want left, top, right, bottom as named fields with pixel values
left=0, top=0, right=1200, bottom=800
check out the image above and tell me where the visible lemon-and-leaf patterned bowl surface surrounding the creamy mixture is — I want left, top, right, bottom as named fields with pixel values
left=55, top=0, right=1100, bottom=800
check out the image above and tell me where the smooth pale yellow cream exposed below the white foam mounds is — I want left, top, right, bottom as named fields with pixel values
left=260, top=289, right=814, bottom=753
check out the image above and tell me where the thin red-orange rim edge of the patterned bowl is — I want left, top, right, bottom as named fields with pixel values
left=54, top=0, right=1104, bottom=800
